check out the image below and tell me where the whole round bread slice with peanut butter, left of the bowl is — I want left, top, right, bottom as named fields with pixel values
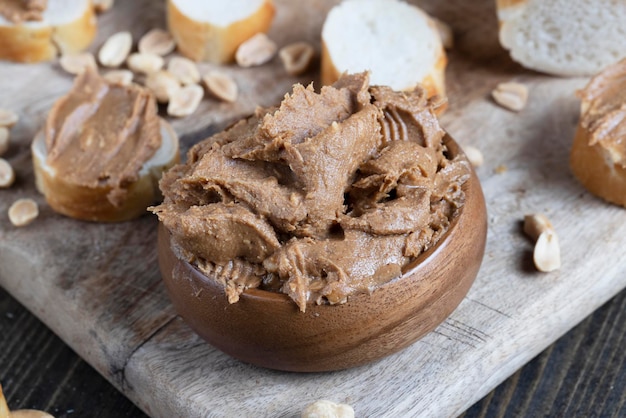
left=31, top=69, right=180, bottom=222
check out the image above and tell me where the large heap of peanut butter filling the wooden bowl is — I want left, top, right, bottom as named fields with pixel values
left=152, top=73, right=470, bottom=312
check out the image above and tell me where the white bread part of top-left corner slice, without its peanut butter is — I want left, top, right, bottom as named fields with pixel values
left=0, top=0, right=96, bottom=62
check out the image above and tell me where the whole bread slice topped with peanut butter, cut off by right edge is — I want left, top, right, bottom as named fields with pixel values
left=570, top=59, right=626, bottom=207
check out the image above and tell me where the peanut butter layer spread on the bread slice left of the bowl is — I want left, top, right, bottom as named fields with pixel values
left=45, top=68, right=161, bottom=207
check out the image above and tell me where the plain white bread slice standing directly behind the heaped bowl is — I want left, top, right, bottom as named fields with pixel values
left=321, top=0, right=447, bottom=97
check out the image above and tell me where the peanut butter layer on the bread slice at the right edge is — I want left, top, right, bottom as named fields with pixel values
left=578, top=60, right=626, bottom=167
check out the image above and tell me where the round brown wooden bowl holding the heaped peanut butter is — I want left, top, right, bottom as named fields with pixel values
left=158, top=136, right=487, bottom=372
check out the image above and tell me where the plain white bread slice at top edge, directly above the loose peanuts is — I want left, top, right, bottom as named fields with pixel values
left=167, top=0, right=275, bottom=64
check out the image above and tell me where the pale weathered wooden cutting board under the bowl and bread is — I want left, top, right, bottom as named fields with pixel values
left=0, top=0, right=626, bottom=417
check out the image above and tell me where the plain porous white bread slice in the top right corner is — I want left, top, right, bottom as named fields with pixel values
left=497, top=0, right=626, bottom=76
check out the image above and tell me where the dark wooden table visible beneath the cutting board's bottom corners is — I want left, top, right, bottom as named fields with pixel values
left=0, top=289, right=626, bottom=418
